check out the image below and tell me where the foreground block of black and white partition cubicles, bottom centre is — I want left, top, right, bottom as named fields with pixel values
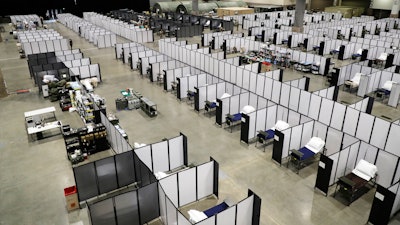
left=73, top=97, right=261, bottom=225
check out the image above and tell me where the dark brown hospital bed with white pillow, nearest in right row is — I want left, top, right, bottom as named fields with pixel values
left=333, top=159, right=378, bottom=205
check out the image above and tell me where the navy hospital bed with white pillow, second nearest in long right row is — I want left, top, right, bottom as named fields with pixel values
left=287, top=137, right=325, bottom=173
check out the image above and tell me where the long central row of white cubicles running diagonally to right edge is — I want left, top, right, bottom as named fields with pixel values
left=112, top=35, right=400, bottom=223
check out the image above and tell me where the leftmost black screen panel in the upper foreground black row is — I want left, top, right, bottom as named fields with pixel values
left=74, top=163, right=99, bottom=201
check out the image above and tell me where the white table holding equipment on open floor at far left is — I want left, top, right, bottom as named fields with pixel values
left=24, top=106, right=61, bottom=141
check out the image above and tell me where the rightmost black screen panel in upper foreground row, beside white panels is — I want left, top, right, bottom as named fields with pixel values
left=114, top=151, right=136, bottom=187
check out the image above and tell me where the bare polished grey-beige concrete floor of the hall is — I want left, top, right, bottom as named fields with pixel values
left=0, top=19, right=400, bottom=225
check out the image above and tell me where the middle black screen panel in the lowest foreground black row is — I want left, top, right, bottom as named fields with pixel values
left=114, top=191, right=140, bottom=225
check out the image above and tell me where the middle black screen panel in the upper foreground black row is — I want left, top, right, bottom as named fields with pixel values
left=95, top=157, right=118, bottom=194
